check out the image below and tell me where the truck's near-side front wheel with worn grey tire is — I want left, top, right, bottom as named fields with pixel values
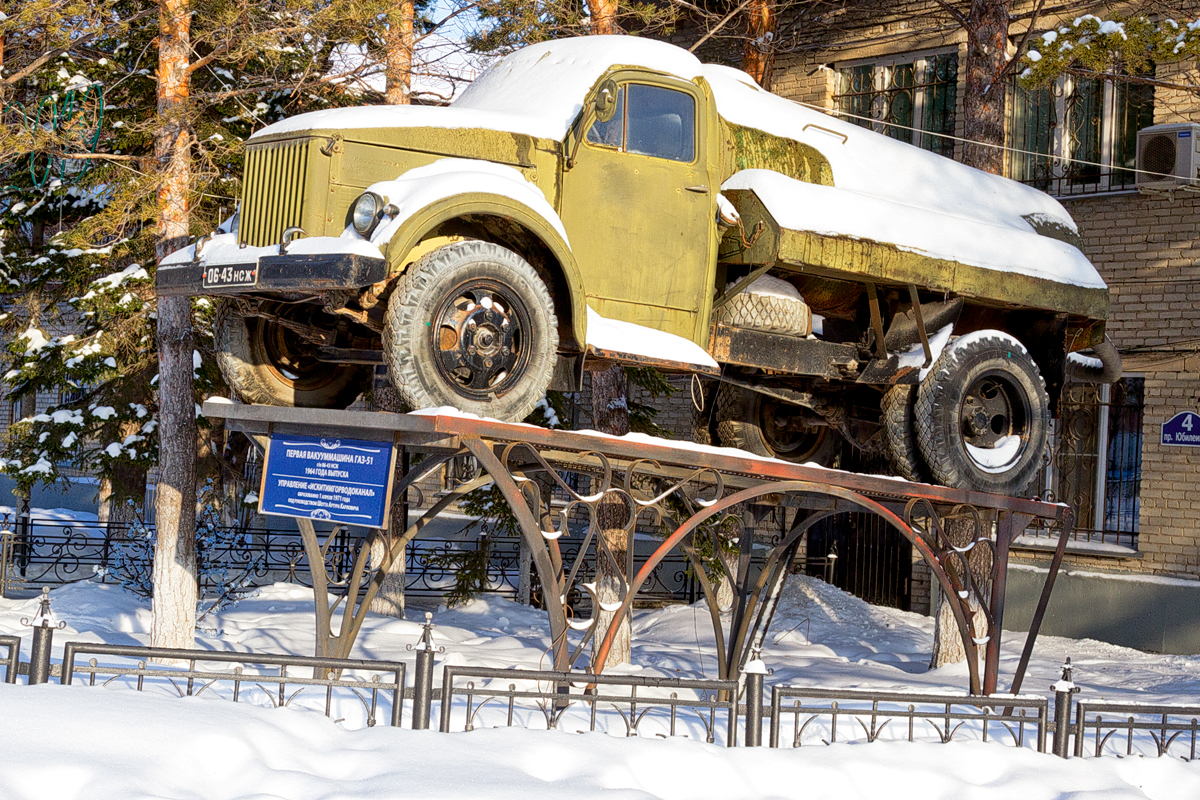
left=383, top=241, right=558, bottom=422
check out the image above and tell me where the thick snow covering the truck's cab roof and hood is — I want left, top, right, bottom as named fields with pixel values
left=251, top=36, right=701, bottom=140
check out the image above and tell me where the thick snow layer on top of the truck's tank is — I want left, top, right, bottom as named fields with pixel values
left=703, top=65, right=1089, bottom=244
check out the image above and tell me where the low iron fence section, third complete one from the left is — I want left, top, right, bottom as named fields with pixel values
left=770, top=686, right=1049, bottom=753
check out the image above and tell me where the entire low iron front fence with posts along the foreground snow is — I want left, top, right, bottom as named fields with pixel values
left=0, top=626, right=1200, bottom=762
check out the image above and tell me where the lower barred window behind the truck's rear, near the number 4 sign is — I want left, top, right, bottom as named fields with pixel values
left=1042, top=374, right=1146, bottom=549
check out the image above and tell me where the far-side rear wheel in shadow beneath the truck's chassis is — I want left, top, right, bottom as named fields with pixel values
left=716, top=384, right=842, bottom=467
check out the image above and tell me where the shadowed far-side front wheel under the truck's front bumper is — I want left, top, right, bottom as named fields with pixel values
left=212, top=300, right=371, bottom=408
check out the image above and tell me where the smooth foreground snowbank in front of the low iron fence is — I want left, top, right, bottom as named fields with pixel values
left=0, top=685, right=1200, bottom=800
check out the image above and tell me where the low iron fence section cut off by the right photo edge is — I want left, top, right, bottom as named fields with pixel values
left=1075, top=700, right=1200, bottom=762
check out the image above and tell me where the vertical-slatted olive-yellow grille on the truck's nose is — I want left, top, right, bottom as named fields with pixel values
left=238, top=139, right=312, bottom=247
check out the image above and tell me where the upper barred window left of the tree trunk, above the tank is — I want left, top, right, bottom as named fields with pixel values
left=834, top=53, right=959, bottom=157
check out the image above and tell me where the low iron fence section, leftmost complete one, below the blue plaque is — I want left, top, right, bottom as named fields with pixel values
left=61, top=642, right=404, bottom=727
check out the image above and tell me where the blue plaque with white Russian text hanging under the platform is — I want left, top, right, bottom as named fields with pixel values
left=258, top=433, right=394, bottom=528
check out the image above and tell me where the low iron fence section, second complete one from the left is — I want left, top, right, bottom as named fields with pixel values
left=440, top=667, right=738, bottom=747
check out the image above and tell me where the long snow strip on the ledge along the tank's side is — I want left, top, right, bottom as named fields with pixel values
left=721, top=169, right=1104, bottom=289
